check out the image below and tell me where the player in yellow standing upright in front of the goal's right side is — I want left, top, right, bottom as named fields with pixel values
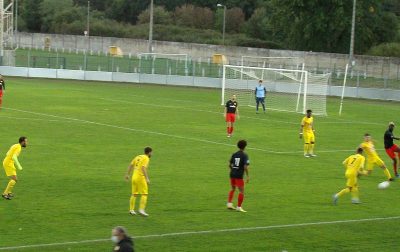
left=300, top=109, right=317, bottom=158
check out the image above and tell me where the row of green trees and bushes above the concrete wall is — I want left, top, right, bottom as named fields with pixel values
left=12, top=0, right=400, bottom=56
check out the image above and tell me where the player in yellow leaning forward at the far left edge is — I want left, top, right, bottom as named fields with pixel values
left=2, top=137, right=28, bottom=200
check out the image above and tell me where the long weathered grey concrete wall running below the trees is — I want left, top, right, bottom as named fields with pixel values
left=14, top=32, right=400, bottom=79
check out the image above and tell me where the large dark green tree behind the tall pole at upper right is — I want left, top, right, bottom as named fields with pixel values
left=269, top=0, right=396, bottom=53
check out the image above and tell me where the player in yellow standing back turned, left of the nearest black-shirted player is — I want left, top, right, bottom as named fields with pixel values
left=125, top=147, right=153, bottom=217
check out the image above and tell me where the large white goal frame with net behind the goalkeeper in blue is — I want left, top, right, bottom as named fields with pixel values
left=222, top=65, right=330, bottom=115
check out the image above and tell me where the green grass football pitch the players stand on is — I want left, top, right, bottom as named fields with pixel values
left=0, top=78, right=400, bottom=251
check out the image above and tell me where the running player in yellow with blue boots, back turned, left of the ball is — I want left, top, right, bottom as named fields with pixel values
left=333, top=147, right=368, bottom=205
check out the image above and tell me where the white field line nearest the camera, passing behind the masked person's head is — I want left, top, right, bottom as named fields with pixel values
left=0, top=216, right=400, bottom=250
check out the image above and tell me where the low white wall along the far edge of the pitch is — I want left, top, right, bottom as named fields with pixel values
left=0, top=66, right=400, bottom=101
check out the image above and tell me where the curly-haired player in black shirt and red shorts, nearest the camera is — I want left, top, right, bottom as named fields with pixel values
left=226, top=140, right=250, bottom=212
